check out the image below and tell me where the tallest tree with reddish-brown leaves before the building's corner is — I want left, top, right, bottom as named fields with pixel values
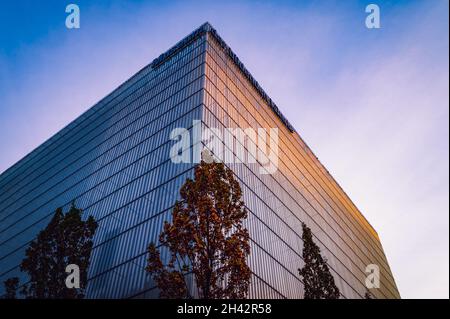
left=146, top=160, right=251, bottom=299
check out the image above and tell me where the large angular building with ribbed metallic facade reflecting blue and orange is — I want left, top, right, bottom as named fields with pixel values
left=0, top=23, right=400, bottom=298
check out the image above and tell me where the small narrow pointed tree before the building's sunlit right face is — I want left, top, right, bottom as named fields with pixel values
left=298, top=223, right=340, bottom=299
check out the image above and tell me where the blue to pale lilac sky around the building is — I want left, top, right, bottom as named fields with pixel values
left=0, top=0, right=449, bottom=298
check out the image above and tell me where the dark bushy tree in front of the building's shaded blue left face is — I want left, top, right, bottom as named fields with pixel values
left=5, top=204, right=98, bottom=299
